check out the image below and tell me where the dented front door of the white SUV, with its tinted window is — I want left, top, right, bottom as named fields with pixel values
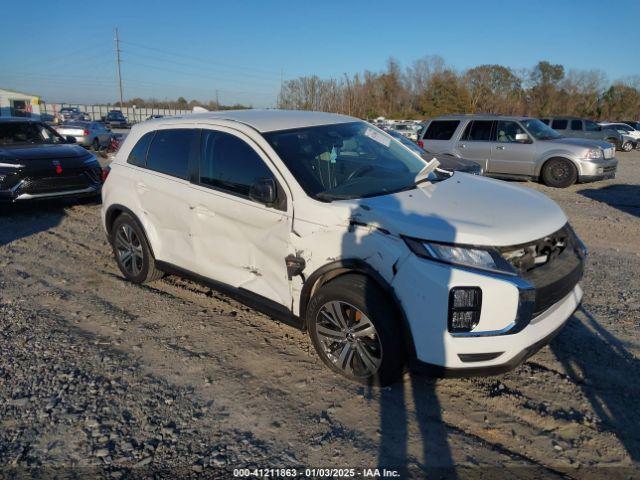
left=189, top=127, right=292, bottom=308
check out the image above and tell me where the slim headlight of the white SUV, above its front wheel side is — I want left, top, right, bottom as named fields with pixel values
left=404, top=237, right=516, bottom=275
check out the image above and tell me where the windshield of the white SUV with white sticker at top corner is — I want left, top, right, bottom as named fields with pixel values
left=264, top=122, right=440, bottom=201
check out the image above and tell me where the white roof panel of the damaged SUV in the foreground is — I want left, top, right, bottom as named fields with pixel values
left=148, top=109, right=361, bottom=132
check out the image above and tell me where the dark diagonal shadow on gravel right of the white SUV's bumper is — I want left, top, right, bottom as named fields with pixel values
left=550, top=307, right=640, bottom=462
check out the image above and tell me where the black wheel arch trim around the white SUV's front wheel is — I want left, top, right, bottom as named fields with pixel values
left=300, top=258, right=416, bottom=359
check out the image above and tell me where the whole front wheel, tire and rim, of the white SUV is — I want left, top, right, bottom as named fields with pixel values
left=307, top=274, right=405, bottom=386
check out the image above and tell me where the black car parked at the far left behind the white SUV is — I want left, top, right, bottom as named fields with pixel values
left=0, top=118, right=103, bottom=203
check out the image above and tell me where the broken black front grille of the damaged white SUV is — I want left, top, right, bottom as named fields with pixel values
left=501, top=224, right=586, bottom=317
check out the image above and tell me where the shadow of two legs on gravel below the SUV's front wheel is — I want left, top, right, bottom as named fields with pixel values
left=378, top=375, right=457, bottom=479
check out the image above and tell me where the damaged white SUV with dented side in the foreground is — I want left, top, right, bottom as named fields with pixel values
left=102, top=110, right=586, bottom=385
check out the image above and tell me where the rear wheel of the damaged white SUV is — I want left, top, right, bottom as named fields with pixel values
left=109, top=213, right=164, bottom=284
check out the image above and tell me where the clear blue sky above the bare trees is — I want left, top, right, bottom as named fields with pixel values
left=0, top=0, right=640, bottom=107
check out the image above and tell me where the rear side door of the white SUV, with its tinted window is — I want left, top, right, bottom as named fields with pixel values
left=129, top=127, right=197, bottom=270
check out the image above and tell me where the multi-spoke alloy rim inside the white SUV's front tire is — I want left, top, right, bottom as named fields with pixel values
left=316, top=301, right=382, bottom=378
